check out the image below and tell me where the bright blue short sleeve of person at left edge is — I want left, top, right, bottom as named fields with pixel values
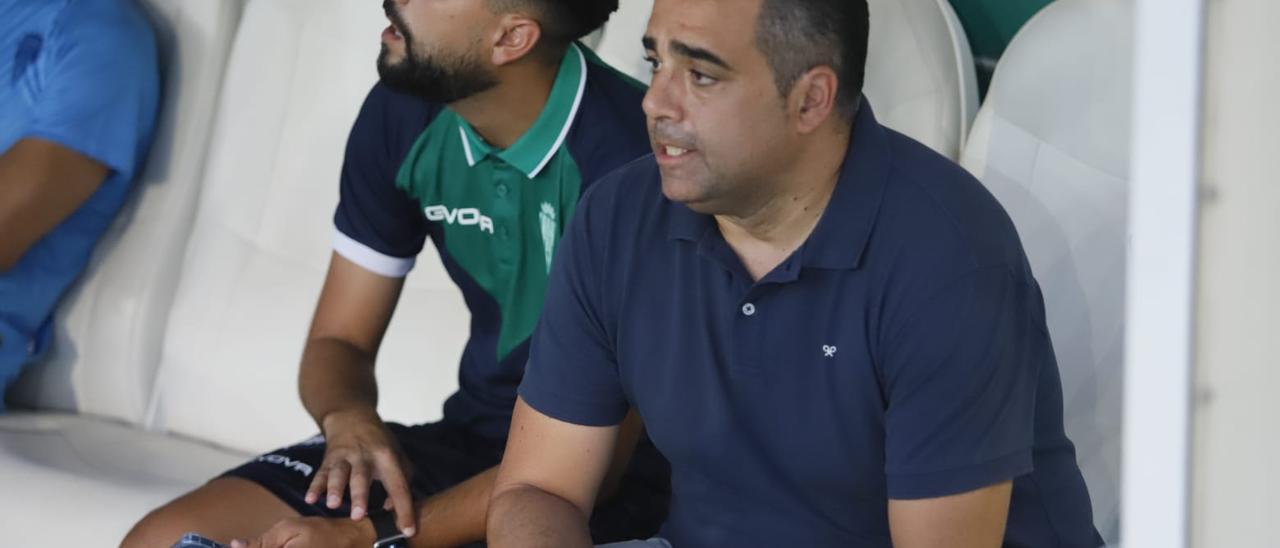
left=27, top=3, right=160, bottom=179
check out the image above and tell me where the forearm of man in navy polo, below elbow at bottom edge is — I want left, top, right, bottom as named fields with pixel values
left=488, top=485, right=591, bottom=548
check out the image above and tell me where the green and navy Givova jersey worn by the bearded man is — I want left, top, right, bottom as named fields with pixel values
left=334, top=45, right=650, bottom=439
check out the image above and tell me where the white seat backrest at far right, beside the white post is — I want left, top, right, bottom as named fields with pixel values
left=963, top=0, right=1133, bottom=542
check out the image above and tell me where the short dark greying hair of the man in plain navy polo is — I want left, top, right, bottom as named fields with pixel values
left=755, top=0, right=870, bottom=119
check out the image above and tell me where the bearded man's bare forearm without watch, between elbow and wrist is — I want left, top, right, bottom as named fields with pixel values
left=298, top=338, right=378, bottom=430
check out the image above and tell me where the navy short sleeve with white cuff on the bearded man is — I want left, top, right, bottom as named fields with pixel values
left=334, top=85, right=428, bottom=278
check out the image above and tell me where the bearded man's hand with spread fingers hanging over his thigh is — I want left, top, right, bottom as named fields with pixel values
left=306, top=410, right=417, bottom=536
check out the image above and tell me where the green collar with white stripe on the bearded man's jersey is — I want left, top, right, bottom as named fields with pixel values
left=458, top=44, right=586, bottom=179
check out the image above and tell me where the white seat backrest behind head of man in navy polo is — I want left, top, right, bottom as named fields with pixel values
left=596, top=0, right=978, bottom=160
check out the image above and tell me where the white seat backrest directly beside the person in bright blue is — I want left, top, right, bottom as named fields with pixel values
left=13, top=0, right=241, bottom=423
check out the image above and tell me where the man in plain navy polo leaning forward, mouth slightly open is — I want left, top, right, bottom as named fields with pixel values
left=489, top=0, right=1101, bottom=548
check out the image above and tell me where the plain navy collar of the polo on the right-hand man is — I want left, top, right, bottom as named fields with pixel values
left=668, top=97, right=892, bottom=269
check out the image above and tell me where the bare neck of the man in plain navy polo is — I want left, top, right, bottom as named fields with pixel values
left=716, top=128, right=849, bottom=280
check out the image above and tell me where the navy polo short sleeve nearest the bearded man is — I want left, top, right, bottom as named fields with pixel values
left=520, top=184, right=628, bottom=426
